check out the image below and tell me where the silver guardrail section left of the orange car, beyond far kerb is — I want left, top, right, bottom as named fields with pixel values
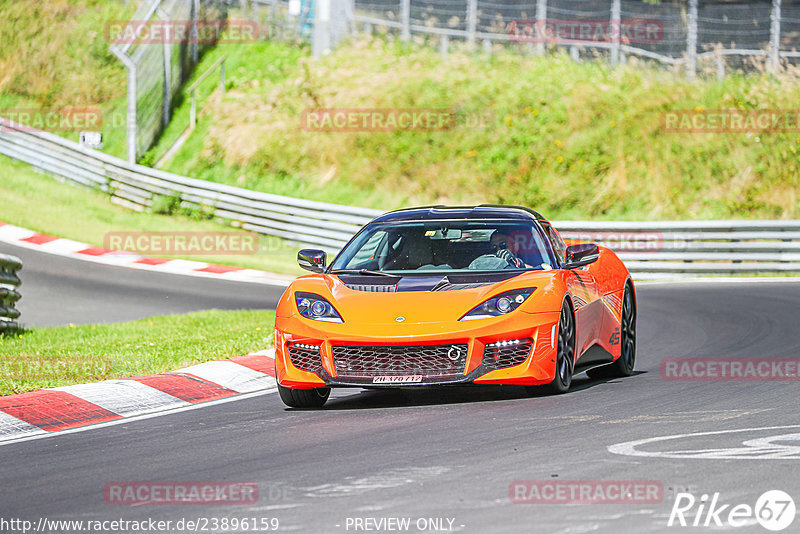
left=0, top=118, right=381, bottom=250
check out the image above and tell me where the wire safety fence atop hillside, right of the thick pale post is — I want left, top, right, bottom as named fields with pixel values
left=354, top=0, right=800, bottom=77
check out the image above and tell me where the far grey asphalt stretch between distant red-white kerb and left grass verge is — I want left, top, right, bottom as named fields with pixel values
left=0, top=243, right=284, bottom=327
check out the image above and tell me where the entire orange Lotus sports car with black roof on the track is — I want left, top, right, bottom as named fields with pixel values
left=275, top=206, right=636, bottom=408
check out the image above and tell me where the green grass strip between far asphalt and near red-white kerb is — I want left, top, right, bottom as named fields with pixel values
left=0, top=311, right=275, bottom=395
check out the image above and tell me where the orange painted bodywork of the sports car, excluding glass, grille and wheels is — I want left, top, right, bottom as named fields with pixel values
left=275, top=243, right=630, bottom=388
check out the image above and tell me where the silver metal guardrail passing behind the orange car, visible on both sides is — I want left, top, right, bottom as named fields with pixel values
left=0, top=118, right=800, bottom=279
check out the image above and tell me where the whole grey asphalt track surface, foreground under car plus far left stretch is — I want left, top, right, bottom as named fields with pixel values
left=0, top=270, right=800, bottom=533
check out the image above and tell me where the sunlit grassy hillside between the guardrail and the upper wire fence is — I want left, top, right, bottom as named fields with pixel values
left=159, top=39, right=800, bottom=219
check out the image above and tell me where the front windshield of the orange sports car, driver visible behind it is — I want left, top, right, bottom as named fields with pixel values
left=331, top=220, right=552, bottom=274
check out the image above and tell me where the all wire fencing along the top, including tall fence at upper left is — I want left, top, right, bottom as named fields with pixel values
left=109, top=0, right=800, bottom=163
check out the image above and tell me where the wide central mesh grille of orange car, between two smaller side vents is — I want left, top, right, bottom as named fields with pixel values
left=333, top=343, right=468, bottom=382
